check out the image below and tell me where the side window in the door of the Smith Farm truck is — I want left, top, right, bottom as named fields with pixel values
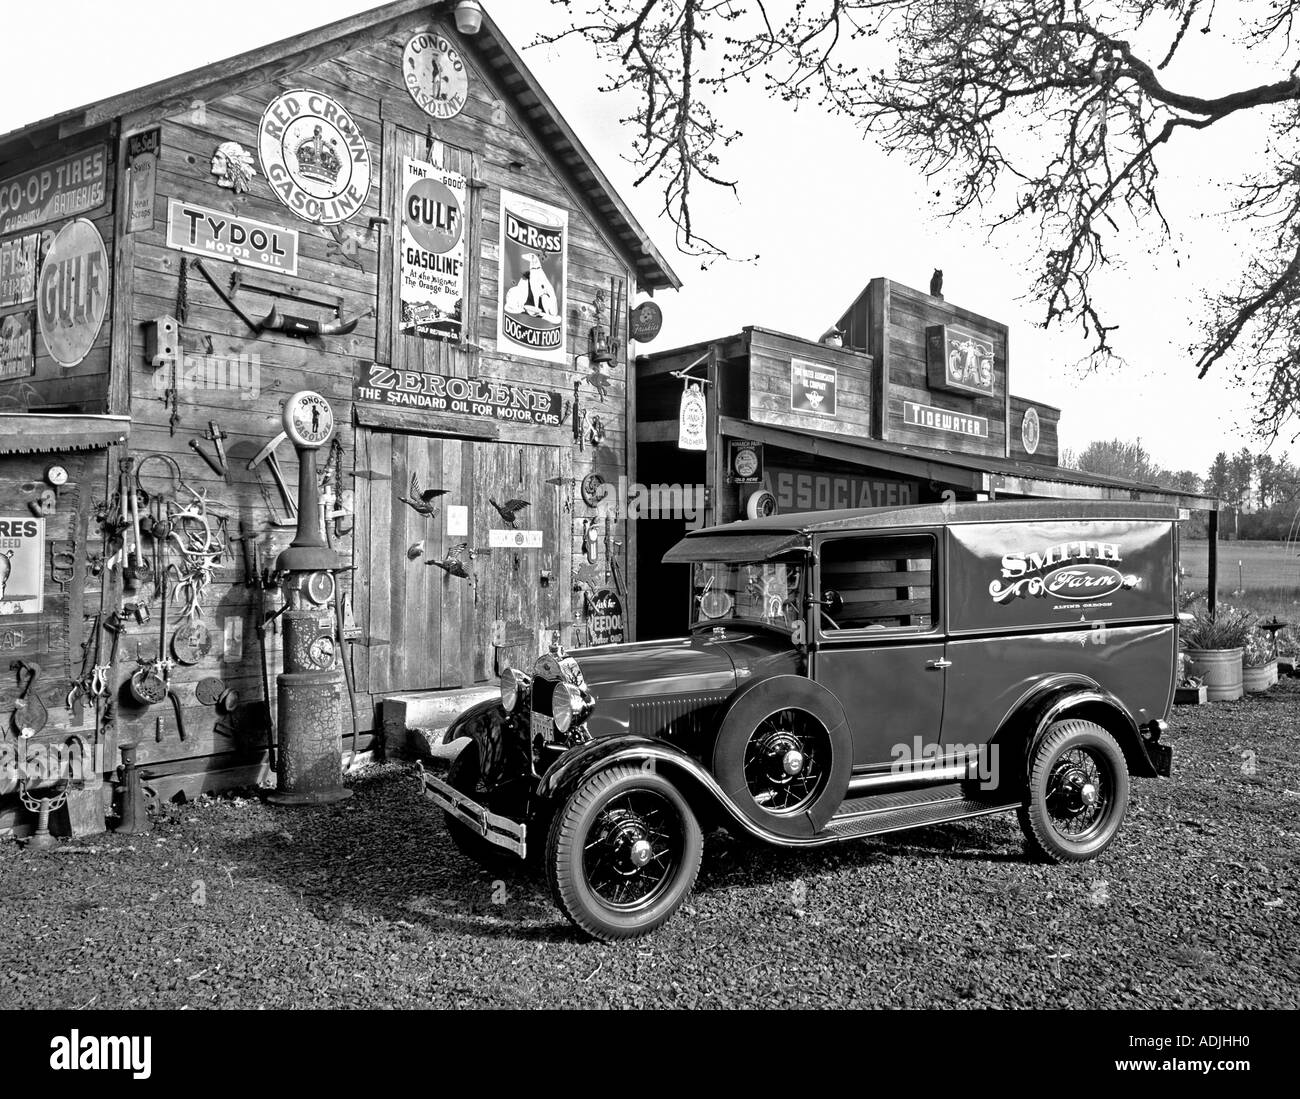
left=822, top=535, right=936, bottom=629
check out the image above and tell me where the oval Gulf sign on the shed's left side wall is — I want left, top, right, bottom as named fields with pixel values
left=36, top=217, right=108, bottom=367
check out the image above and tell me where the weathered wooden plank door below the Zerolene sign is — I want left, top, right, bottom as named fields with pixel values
left=354, top=429, right=571, bottom=695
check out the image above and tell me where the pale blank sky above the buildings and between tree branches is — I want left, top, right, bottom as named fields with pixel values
left=0, top=0, right=1300, bottom=476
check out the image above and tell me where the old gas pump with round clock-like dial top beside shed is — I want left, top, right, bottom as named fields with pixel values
left=268, top=390, right=352, bottom=805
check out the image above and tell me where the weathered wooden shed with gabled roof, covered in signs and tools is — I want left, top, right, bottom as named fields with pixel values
left=0, top=0, right=680, bottom=827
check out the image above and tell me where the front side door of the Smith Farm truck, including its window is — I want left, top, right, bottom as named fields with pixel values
left=813, top=532, right=945, bottom=770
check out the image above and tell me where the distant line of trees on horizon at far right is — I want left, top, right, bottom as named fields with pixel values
left=1061, top=438, right=1300, bottom=540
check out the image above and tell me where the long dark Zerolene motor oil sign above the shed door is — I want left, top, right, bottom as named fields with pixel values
left=355, top=363, right=563, bottom=428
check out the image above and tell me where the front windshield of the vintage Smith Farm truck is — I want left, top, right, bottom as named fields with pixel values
left=690, top=561, right=803, bottom=631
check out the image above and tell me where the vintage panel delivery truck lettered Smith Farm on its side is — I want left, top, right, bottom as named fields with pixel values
left=421, top=501, right=1179, bottom=939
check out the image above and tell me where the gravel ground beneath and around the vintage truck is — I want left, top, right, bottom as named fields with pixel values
left=0, top=680, right=1300, bottom=1008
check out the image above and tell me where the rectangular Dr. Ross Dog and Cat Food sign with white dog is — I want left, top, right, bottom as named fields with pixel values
left=497, top=190, right=568, bottom=363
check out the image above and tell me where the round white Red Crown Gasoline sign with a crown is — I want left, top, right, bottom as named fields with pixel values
left=257, top=88, right=372, bottom=225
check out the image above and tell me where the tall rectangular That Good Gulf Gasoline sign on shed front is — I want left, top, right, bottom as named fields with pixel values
left=400, top=157, right=467, bottom=339
